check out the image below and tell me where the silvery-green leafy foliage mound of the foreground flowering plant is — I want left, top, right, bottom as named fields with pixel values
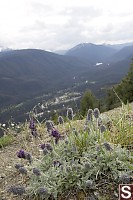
left=27, top=108, right=133, bottom=199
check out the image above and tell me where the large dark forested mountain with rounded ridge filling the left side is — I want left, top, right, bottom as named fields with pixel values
left=0, top=49, right=88, bottom=107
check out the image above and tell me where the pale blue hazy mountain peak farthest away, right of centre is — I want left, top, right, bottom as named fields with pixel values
left=66, top=43, right=117, bottom=64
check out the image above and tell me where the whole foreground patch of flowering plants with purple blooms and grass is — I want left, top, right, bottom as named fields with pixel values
left=3, top=106, right=133, bottom=200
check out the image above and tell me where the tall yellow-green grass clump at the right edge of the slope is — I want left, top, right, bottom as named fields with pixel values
left=104, top=104, right=133, bottom=149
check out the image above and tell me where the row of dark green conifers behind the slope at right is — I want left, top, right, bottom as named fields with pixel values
left=80, top=59, right=133, bottom=116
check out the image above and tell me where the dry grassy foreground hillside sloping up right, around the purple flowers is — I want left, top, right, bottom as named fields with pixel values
left=0, top=103, right=133, bottom=200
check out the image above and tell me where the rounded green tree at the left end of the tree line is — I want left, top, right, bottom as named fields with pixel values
left=80, top=90, right=97, bottom=116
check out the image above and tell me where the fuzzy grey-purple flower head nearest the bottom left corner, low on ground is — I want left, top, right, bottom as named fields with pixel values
left=7, top=185, right=26, bottom=196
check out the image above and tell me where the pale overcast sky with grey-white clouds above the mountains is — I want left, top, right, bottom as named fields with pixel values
left=0, top=0, right=133, bottom=51
